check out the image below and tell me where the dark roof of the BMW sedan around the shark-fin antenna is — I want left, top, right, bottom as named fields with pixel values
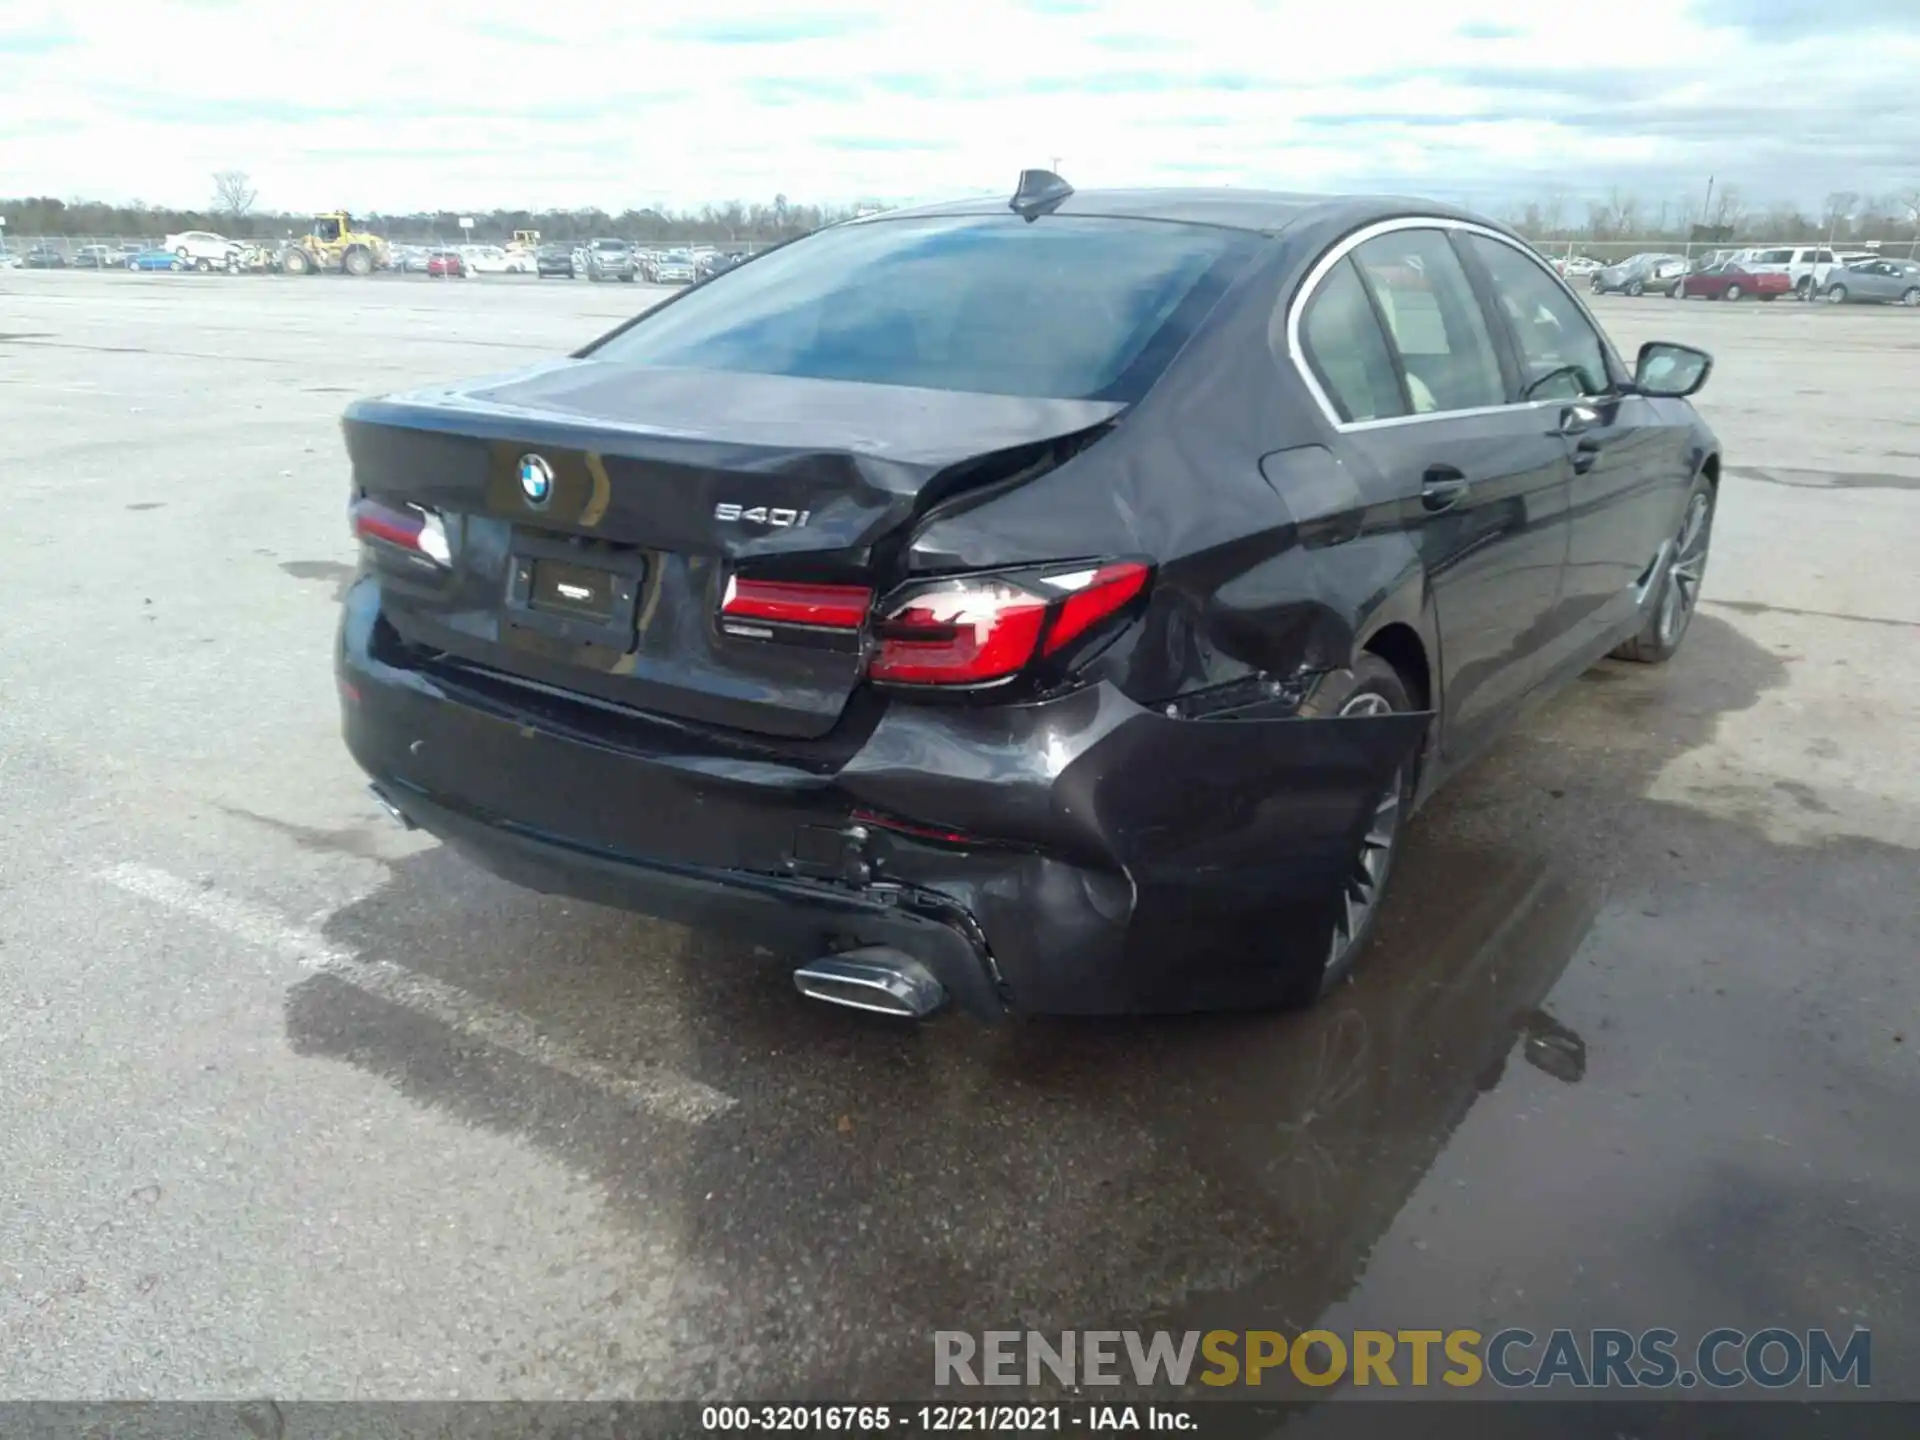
left=847, top=186, right=1492, bottom=234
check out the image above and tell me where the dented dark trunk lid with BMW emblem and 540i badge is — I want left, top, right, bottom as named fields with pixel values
left=342, top=359, right=1123, bottom=739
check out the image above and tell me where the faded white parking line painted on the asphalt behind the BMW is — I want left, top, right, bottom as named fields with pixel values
left=100, top=864, right=737, bottom=1125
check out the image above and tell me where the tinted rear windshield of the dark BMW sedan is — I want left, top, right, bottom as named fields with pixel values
left=589, top=215, right=1260, bottom=401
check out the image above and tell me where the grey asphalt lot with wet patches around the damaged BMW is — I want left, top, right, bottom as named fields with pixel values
left=0, top=273, right=1920, bottom=1400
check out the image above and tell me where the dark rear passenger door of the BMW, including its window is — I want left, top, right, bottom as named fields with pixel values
left=1302, top=227, right=1569, bottom=755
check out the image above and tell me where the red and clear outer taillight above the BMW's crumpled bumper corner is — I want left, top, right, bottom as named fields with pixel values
left=868, top=561, right=1152, bottom=685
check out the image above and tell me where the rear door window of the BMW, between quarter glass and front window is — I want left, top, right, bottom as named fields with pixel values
left=1354, top=230, right=1507, bottom=415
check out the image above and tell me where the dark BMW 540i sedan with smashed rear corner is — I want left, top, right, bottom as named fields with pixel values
left=338, top=171, right=1720, bottom=1016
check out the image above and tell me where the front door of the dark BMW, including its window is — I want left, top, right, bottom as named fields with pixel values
left=1461, top=232, right=1690, bottom=652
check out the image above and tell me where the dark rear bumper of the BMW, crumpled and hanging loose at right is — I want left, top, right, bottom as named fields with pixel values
left=338, top=580, right=1430, bottom=1014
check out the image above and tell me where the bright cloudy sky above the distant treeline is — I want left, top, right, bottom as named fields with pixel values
left=0, top=0, right=1920, bottom=211
